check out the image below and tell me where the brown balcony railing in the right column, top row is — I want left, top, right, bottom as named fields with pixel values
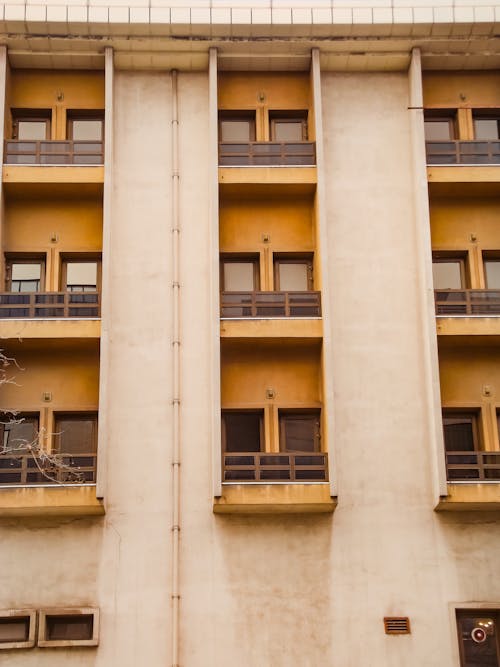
left=425, top=141, right=500, bottom=165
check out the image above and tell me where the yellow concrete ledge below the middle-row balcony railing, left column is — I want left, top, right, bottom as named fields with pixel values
left=0, top=319, right=101, bottom=340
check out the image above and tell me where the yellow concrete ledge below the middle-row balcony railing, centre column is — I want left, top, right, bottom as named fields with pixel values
left=220, top=318, right=323, bottom=338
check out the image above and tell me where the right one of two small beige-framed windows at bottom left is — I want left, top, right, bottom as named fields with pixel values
left=38, top=608, right=99, bottom=647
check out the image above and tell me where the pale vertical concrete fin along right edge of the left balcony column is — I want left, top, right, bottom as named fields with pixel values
left=96, top=47, right=114, bottom=498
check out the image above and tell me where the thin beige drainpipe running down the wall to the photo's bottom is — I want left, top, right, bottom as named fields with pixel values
left=171, top=70, right=181, bottom=667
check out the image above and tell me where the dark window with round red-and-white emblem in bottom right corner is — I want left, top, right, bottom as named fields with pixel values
left=456, top=609, right=500, bottom=667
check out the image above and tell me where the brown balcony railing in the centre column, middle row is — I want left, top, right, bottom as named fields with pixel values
left=221, top=292, right=321, bottom=318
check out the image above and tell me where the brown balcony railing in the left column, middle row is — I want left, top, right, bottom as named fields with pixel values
left=0, top=292, right=101, bottom=319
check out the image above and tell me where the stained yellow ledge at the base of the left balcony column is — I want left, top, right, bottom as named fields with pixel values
left=0, top=485, right=104, bottom=518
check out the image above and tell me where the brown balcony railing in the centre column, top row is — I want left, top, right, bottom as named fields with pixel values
left=219, top=141, right=316, bottom=167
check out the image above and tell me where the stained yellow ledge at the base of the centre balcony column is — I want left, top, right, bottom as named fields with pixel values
left=213, top=484, right=337, bottom=514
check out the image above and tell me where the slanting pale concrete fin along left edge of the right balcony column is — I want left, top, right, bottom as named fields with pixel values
left=408, top=48, right=447, bottom=503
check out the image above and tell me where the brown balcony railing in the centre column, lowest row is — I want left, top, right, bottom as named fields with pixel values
left=222, top=452, right=328, bottom=484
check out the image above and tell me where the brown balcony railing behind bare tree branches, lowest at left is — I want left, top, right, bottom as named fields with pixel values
left=0, top=452, right=97, bottom=486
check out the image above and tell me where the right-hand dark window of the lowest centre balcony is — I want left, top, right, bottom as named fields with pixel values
left=279, top=410, right=321, bottom=452
